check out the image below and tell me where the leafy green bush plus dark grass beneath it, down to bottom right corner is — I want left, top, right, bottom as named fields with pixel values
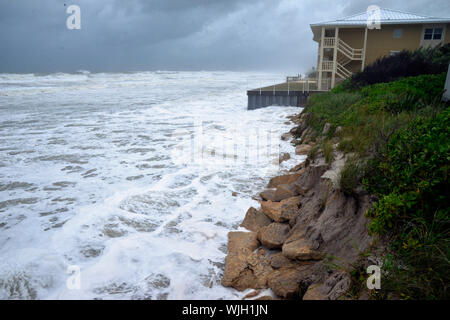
left=364, top=108, right=450, bottom=299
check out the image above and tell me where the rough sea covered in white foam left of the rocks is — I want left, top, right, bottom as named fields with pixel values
left=0, top=71, right=301, bottom=299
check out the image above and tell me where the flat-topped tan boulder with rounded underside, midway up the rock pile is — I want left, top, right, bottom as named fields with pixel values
left=260, top=197, right=301, bottom=222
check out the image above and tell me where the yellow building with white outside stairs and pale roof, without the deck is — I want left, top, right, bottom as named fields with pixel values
left=311, top=9, right=450, bottom=91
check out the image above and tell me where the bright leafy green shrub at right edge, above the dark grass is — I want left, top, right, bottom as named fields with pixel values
left=365, top=109, right=450, bottom=231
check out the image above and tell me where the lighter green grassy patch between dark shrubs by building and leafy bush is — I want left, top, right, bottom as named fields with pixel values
left=305, top=74, right=445, bottom=156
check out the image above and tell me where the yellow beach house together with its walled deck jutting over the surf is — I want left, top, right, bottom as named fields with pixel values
left=247, top=7, right=450, bottom=109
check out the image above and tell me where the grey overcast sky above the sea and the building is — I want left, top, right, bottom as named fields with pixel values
left=0, top=0, right=450, bottom=74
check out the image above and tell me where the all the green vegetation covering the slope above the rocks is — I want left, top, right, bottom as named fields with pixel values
left=304, top=45, right=450, bottom=299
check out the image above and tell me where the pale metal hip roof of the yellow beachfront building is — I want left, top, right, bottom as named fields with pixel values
left=311, top=8, right=450, bottom=27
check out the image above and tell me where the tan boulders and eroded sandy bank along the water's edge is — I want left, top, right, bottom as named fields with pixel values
left=221, top=109, right=373, bottom=300
